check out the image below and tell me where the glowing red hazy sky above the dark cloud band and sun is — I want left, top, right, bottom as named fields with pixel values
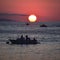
left=0, top=0, right=60, bottom=20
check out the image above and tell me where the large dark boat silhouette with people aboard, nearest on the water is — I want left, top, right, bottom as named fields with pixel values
left=6, top=35, right=38, bottom=44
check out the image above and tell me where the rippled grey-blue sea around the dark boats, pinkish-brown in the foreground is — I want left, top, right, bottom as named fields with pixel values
left=0, top=21, right=60, bottom=60
